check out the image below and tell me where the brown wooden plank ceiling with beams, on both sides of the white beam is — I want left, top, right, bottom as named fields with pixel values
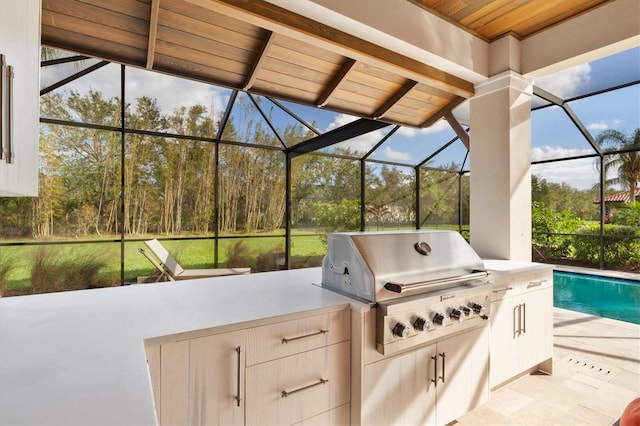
left=42, top=0, right=602, bottom=127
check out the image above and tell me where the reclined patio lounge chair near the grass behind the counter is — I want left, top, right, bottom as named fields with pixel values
left=138, top=239, right=251, bottom=282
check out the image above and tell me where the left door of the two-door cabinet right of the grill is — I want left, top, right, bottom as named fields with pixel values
left=489, top=297, right=520, bottom=388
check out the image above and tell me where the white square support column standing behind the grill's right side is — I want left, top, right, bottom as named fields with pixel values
left=470, top=71, right=532, bottom=261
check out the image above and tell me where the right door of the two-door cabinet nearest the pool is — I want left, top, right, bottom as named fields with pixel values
left=518, top=288, right=553, bottom=372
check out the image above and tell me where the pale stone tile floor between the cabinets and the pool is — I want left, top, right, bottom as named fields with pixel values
left=454, top=306, right=640, bottom=426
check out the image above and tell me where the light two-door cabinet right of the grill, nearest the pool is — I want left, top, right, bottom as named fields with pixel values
left=490, top=268, right=553, bottom=389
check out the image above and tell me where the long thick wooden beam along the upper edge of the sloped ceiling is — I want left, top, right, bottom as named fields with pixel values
left=185, top=0, right=474, bottom=98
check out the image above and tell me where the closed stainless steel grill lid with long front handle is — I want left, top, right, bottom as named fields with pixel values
left=322, top=230, right=487, bottom=302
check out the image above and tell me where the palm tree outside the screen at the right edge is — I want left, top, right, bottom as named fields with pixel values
left=596, top=128, right=640, bottom=202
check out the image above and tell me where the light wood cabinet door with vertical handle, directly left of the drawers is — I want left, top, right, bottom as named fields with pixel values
left=189, top=331, right=245, bottom=425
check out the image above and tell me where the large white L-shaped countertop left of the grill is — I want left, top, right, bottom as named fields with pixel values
left=0, top=268, right=353, bottom=425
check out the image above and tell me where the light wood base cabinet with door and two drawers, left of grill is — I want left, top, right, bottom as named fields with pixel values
left=147, top=309, right=351, bottom=425
